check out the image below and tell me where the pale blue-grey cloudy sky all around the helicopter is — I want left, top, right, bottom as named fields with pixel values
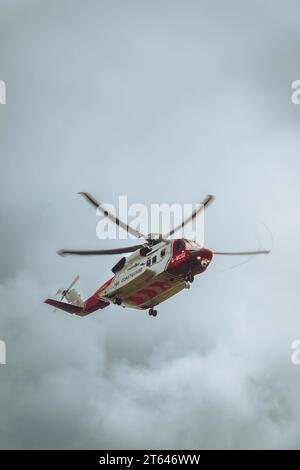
left=0, top=0, right=300, bottom=449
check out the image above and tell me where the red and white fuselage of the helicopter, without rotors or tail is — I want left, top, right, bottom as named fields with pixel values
left=84, top=239, right=213, bottom=313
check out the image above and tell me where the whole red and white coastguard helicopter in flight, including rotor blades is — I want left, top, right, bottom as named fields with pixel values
left=45, top=193, right=270, bottom=317
